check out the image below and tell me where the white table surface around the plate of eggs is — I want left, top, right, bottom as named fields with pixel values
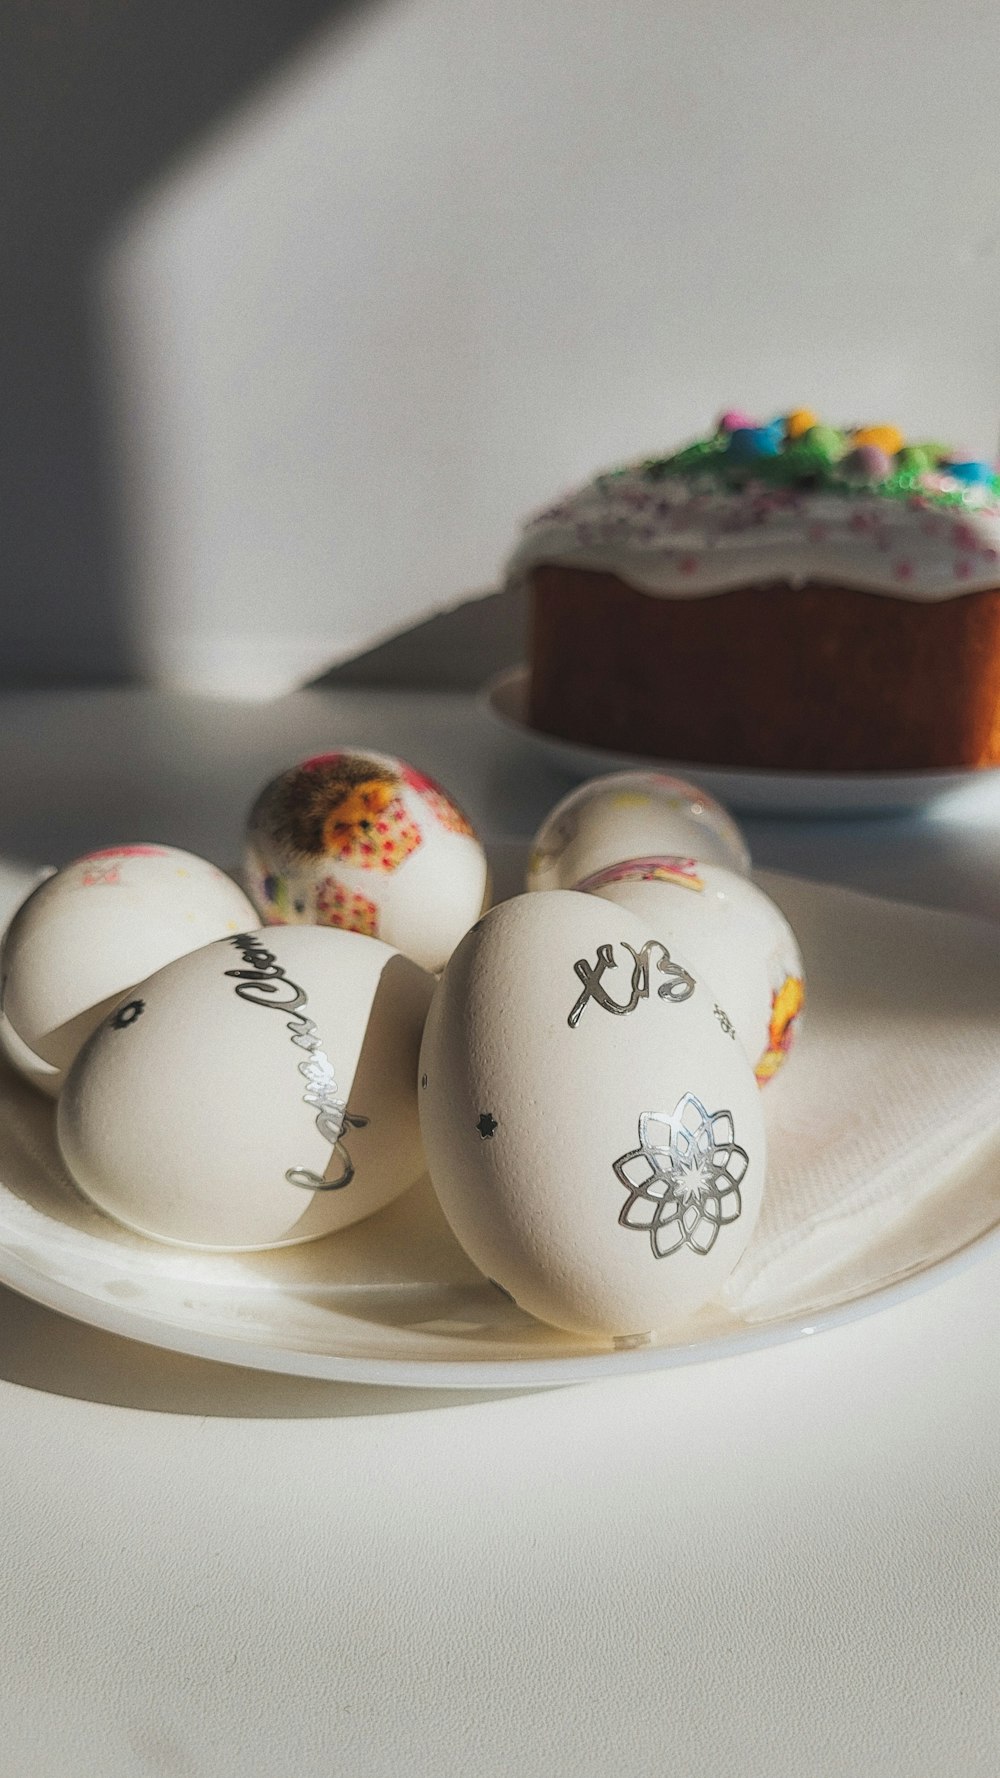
left=0, top=692, right=1000, bottom=1778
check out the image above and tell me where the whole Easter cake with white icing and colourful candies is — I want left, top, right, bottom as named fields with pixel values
left=509, top=409, right=1000, bottom=772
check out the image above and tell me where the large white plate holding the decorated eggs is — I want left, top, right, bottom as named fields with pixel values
left=0, top=860, right=1000, bottom=1389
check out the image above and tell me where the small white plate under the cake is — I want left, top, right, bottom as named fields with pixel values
left=482, top=667, right=1000, bottom=816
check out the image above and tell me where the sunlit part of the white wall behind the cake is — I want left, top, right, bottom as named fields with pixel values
left=103, top=0, right=1000, bottom=692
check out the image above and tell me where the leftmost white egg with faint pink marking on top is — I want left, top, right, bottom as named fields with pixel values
left=0, top=845, right=258, bottom=1095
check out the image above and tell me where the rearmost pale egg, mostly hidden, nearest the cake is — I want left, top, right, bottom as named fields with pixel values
left=527, top=772, right=749, bottom=889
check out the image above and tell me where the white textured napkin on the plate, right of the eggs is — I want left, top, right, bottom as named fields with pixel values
left=724, top=873, right=1000, bottom=1321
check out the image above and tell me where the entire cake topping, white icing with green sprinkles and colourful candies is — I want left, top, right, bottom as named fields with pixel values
left=507, top=411, right=1000, bottom=601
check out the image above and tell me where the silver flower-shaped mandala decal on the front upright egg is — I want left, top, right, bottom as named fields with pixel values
left=614, top=1093, right=749, bottom=1259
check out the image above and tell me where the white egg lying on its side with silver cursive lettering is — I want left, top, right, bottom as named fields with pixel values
left=59, top=926, right=434, bottom=1250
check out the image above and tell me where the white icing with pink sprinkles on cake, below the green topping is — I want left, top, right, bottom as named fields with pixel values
left=507, top=466, right=1000, bottom=601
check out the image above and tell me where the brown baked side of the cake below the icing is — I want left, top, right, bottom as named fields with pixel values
left=528, top=564, right=1000, bottom=772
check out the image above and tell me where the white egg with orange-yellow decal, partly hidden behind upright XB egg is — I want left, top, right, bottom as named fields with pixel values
left=580, top=859, right=806, bottom=1085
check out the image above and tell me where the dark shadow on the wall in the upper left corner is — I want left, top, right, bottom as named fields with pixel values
left=0, top=0, right=372, bottom=685
